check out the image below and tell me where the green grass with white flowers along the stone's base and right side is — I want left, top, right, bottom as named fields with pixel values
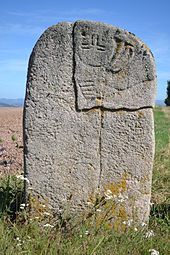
left=0, top=107, right=170, bottom=255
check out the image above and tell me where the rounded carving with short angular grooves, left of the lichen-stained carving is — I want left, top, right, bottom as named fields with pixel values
left=75, top=26, right=116, bottom=67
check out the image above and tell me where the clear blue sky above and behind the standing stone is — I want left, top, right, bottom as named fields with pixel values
left=0, top=0, right=170, bottom=100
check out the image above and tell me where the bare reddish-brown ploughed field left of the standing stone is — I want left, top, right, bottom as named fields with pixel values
left=0, top=107, right=23, bottom=176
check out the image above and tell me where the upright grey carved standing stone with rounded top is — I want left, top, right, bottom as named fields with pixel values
left=24, top=21, right=156, bottom=226
